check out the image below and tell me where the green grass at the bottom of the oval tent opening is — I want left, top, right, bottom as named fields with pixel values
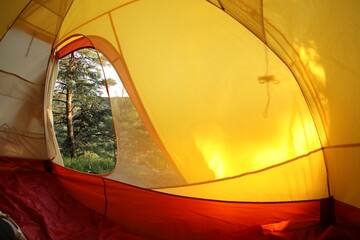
left=63, top=156, right=115, bottom=174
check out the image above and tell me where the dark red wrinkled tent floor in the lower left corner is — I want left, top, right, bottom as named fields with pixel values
left=0, top=172, right=142, bottom=240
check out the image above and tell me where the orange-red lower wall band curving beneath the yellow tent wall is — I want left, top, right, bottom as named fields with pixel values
left=54, top=165, right=321, bottom=239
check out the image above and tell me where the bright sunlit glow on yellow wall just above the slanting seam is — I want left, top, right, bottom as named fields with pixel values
left=194, top=114, right=320, bottom=179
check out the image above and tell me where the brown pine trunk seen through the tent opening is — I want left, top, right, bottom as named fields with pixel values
left=66, top=53, right=76, bottom=159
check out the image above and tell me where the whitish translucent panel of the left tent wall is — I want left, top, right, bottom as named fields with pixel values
left=0, top=26, right=51, bottom=159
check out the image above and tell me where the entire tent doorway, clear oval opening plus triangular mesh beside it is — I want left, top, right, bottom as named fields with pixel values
left=52, top=48, right=186, bottom=188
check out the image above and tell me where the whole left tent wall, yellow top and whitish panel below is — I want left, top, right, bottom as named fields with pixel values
left=0, top=1, right=71, bottom=160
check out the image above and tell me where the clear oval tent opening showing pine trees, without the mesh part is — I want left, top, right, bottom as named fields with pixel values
left=53, top=49, right=116, bottom=174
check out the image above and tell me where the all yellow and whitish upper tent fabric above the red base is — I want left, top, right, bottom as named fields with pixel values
left=0, top=0, right=360, bottom=210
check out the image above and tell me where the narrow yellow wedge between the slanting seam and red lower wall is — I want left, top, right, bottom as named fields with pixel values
left=159, top=151, right=328, bottom=202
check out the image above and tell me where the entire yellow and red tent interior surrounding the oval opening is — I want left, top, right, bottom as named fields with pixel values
left=0, top=0, right=360, bottom=239
